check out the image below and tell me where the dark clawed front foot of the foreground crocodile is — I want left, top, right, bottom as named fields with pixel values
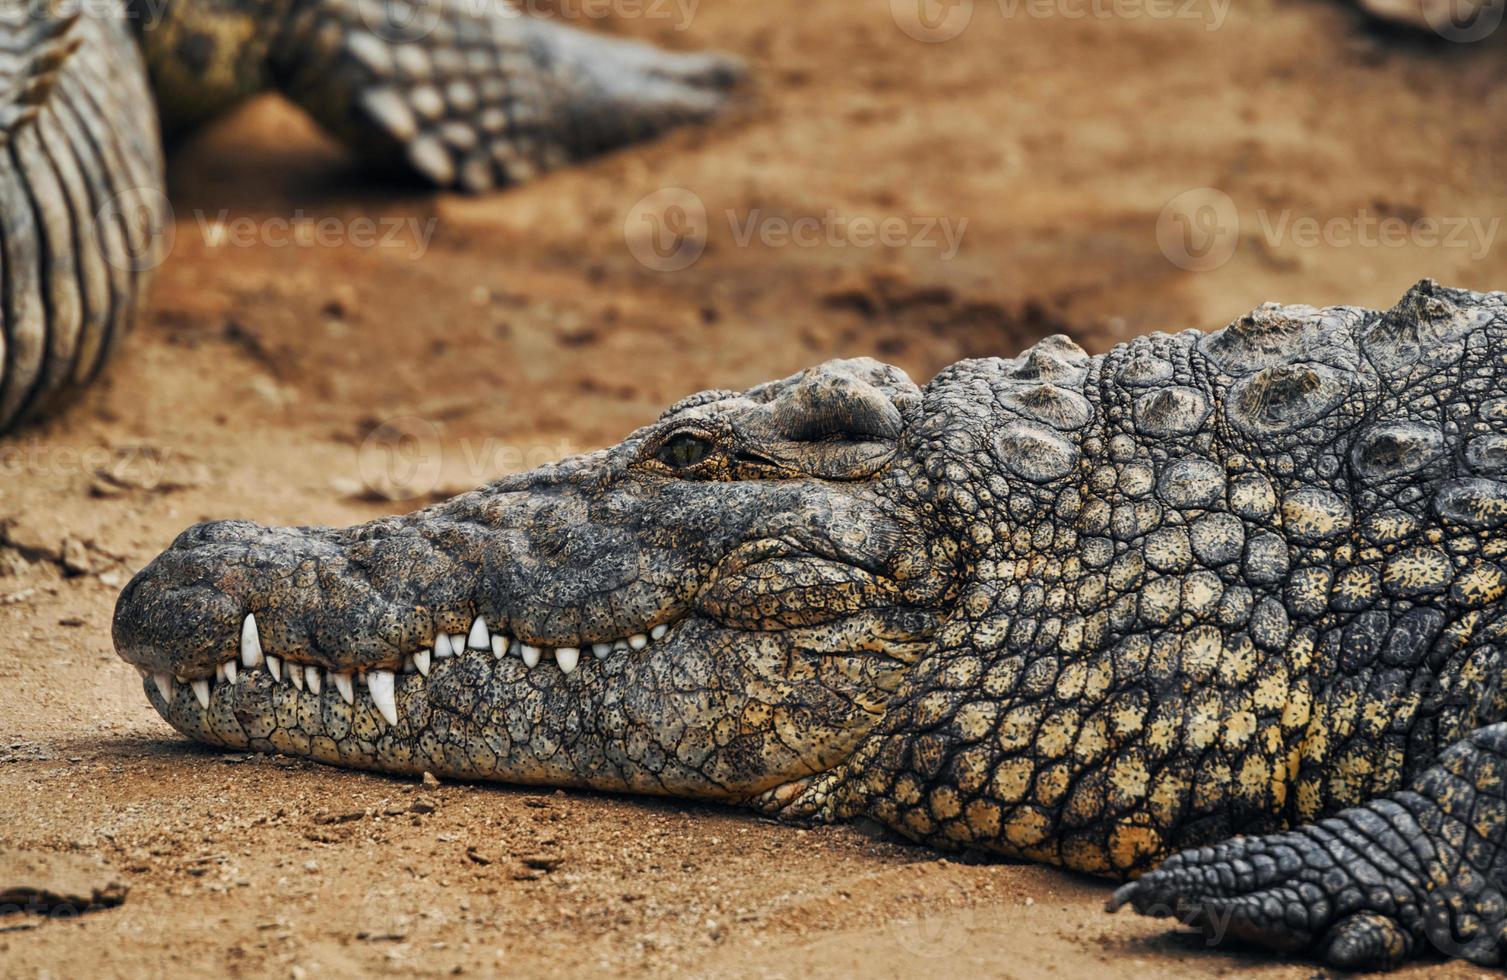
left=1109, top=724, right=1507, bottom=969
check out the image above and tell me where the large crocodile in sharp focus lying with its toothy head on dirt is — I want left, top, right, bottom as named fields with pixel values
left=113, top=280, right=1507, bottom=968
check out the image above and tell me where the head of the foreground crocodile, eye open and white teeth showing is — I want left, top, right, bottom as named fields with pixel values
left=115, top=360, right=952, bottom=808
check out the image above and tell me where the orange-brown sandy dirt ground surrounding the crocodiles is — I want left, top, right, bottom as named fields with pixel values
left=0, top=0, right=1507, bottom=978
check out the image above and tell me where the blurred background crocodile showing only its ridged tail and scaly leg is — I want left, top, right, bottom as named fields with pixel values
left=0, top=0, right=744, bottom=433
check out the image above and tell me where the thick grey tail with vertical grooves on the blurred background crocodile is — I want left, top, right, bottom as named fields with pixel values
left=0, top=5, right=167, bottom=433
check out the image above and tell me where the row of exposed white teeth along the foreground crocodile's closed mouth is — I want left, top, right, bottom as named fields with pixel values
left=137, top=614, right=674, bottom=725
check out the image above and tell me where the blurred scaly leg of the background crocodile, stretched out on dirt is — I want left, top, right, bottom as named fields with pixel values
left=268, top=0, right=743, bottom=193
